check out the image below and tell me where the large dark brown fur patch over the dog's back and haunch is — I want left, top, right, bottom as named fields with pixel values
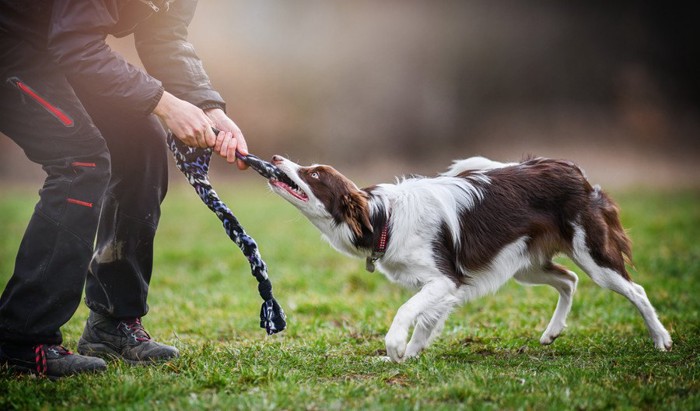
left=433, top=158, right=629, bottom=282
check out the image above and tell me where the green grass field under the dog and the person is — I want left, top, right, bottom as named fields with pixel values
left=0, top=180, right=700, bottom=410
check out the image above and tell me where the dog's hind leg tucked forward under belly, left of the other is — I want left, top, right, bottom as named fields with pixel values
left=514, top=261, right=578, bottom=345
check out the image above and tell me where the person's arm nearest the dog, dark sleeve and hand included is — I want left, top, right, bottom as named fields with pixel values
left=134, top=0, right=248, bottom=169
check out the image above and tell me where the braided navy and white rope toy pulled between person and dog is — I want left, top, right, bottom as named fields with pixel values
left=168, top=134, right=287, bottom=335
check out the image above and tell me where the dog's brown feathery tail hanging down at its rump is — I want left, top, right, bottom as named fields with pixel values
left=586, top=185, right=632, bottom=280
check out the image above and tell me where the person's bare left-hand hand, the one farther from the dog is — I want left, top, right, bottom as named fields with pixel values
left=153, top=91, right=216, bottom=148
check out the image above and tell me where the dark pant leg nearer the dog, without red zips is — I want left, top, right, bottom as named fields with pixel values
left=71, top=79, right=168, bottom=318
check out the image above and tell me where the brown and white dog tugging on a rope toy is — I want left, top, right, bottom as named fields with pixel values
left=270, top=156, right=672, bottom=362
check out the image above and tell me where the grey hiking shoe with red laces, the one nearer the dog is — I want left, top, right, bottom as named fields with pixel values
left=78, top=311, right=180, bottom=364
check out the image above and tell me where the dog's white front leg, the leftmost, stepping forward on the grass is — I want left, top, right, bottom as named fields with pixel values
left=384, top=279, right=455, bottom=362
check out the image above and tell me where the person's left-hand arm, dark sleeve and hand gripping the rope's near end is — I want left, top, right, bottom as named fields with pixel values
left=48, top=0, right=216, bottom=147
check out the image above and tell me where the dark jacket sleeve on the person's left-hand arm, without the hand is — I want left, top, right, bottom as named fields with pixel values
left=48, top=0, right=163, bottom=114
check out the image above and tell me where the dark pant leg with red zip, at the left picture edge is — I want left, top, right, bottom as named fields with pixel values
left=0, top=36, right=110, bottom=344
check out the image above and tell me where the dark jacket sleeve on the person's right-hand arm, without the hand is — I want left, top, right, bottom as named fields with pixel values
left=134, top=0, right=226, bottom=110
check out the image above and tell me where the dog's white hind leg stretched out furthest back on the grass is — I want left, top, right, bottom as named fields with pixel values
left=572, top=226, right=673, bottom=351
